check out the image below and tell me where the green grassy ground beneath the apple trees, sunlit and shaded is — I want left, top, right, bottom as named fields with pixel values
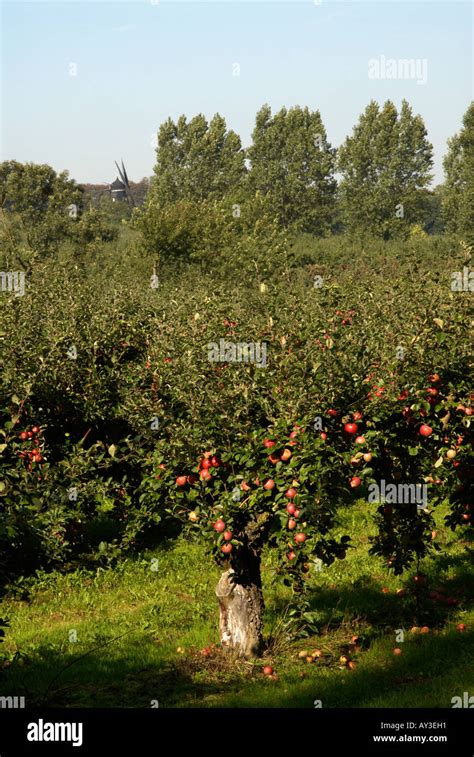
left=0, top=502, right=474, bottom=708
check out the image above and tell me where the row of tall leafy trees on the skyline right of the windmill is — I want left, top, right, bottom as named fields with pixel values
left=149, top=101, right=474, bottom=239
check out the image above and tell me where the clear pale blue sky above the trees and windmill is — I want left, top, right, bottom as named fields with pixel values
left=0, top=0, right=473, bottom=183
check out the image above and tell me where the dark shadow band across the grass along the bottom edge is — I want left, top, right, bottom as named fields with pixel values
left=0, top=632, right=474, bottom=708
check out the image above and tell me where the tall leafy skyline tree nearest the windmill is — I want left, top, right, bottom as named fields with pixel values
left=150, top=113, right=246, bottom=207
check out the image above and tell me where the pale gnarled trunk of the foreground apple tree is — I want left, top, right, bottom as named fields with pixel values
left=216, top=550, right=264, bottom=657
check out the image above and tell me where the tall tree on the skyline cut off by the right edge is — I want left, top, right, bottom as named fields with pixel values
left=443, top=102, right=474, bottom=237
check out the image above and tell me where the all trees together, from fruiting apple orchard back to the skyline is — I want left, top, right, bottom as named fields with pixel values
left=0, top=101, right=474, bottom=656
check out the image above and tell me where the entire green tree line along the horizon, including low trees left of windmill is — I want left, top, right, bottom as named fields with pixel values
left=0, top=100, right=474, bottom=268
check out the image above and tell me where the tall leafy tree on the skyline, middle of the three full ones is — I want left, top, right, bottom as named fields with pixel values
left=247, top=105, right=336, bottom=234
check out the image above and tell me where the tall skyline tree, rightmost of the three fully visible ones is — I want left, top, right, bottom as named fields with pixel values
left=338, top=100, right=433, bottom=239
